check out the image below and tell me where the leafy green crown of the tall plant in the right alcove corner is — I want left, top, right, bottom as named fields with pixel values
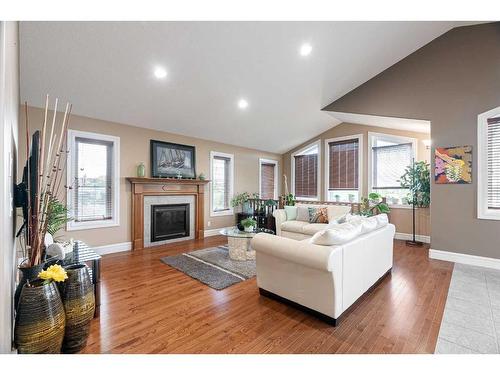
left=399, top=161, right=431, bottom=207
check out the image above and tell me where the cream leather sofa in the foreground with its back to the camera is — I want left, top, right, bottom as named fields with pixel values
left=251, top=223, right=395, bottom=325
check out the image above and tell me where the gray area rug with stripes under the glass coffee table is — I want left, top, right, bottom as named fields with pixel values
left=161, top=246, right=256, bottom=290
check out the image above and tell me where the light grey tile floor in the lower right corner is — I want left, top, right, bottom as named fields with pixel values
left=435, top=263, right=500, bottom=354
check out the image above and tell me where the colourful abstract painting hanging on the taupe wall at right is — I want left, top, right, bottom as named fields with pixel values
left=434, top=146, right=472, bottom=184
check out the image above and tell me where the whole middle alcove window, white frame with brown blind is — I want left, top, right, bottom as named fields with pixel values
left=325, top=134, right=363, bottom=202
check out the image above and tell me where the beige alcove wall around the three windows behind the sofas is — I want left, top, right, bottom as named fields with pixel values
left=283, top=123, right=430, bottom=235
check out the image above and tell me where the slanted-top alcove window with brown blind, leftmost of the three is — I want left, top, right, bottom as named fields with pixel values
left=292, top=141, right=320, bottom=200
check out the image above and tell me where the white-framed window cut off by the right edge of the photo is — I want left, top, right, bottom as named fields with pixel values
left=477, top=107, right=500, bottom=220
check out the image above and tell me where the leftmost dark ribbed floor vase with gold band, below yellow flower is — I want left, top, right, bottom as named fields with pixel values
left=14, top=280, right=66, bottom=354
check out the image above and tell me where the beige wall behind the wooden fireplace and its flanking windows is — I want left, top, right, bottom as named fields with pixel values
left=18, top=107, right=281, bottom=246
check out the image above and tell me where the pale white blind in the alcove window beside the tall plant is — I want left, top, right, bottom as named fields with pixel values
left=372, top=143, right=412, bottom=189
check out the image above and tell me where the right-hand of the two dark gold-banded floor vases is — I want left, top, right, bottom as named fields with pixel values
left=59, top=264, right=95, bottom=353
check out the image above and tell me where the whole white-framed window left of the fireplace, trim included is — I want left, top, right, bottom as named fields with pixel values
left=67, top=130, right=120, bottom=230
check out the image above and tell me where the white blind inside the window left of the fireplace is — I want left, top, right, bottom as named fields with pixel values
left=72, top=137, right=113, bottom=222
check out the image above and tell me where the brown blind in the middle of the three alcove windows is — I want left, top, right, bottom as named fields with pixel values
left=328, top=139, right=359, bottom=190
